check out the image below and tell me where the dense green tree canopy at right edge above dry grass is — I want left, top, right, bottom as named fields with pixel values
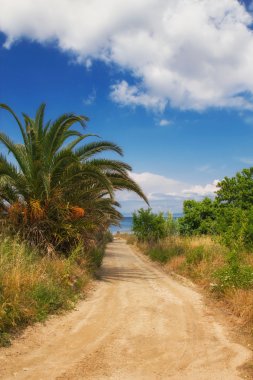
left=179, top=168, right=253, bottom=247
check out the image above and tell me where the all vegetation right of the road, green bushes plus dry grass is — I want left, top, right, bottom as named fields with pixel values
left=128, top=168, right=253, bottom=332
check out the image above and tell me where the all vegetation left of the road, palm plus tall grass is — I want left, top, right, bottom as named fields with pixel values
left=0, top=104, right=147, bottom=345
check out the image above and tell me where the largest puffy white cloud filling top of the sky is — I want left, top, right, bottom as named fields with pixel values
left=0, top=0, right=253, bottom=110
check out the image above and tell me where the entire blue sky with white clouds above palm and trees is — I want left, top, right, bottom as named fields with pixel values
left=0, top=0, right=253, bottom=214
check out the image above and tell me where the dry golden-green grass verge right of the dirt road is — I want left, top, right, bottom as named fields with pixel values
left=128, top=235, right=253, bottom=334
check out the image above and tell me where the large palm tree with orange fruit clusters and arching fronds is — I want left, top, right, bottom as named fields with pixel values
left=0, top=104, right=147, bottom=251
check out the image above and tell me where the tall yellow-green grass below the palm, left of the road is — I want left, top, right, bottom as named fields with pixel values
left=0, top=236, right=104, bottom=345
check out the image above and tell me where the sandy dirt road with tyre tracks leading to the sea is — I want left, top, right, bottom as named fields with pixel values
left=0, top=240, right=250, bottom=380
